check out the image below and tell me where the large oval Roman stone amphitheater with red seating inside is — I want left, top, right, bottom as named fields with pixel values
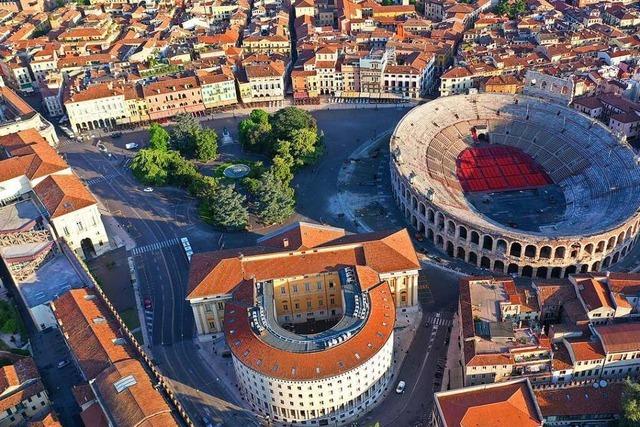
left=390, top=94, right=640, bottom=277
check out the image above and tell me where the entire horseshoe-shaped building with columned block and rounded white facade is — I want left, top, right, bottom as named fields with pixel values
left=187, top=223, right=420, bottom=426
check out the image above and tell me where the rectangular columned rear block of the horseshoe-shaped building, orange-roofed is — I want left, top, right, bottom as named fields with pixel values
left=187, top=222, right=420, bottom=335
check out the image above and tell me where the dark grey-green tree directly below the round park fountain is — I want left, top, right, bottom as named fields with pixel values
left=200, top=185, right=249, bottom=230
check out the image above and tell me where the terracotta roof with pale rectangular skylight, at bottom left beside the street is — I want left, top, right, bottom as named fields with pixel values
left=92, top=359, right=178, bottom=427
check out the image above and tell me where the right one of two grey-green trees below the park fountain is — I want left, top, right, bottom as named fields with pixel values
left=257, top=168, right=296, bottom=225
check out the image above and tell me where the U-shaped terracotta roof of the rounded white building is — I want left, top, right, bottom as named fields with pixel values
left=224, top=282, right=395, bottom=381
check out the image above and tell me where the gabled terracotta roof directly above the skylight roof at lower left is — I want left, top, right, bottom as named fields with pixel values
left=53, top=288, right=132, bottom=380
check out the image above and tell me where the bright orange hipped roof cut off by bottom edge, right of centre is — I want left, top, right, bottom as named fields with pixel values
left=435, top=380, right=542, bottom=427
